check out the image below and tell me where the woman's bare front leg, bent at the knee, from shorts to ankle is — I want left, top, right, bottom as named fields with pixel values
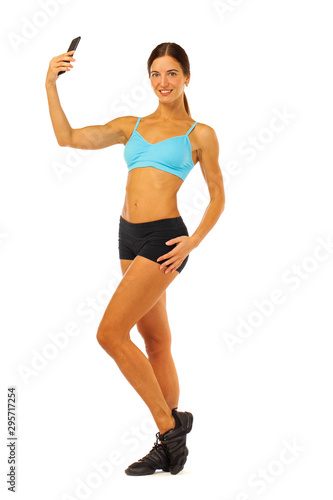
left=97, top=256, right=179, bottom=434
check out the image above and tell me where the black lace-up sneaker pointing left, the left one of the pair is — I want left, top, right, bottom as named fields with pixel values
left=125, top=433, right=170, bottom=476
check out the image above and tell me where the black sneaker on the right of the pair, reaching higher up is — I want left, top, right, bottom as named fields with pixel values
left=156, top=409, right=193, bottom=474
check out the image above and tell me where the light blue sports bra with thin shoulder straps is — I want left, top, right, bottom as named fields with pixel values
left=124, top=117, right=198, bottom=181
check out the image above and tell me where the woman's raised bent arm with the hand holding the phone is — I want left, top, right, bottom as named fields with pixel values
left=45, top=51, right=126, bottom=149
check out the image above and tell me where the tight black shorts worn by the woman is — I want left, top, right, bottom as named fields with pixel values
left=118, top=216, right=189, bottom=273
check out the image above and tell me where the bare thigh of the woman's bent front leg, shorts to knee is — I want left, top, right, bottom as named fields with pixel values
left=100, top=255, right=179, bottom=334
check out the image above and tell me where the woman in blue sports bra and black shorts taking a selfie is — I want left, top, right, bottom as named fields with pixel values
left=45, top=43, right=224, bottom=475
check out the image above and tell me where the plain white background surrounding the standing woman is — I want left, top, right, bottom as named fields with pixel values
left=0, top=0, right=333, bottom=500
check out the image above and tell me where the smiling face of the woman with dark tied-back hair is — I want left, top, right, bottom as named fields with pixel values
left=150, top=56, right=190, bottom=102
